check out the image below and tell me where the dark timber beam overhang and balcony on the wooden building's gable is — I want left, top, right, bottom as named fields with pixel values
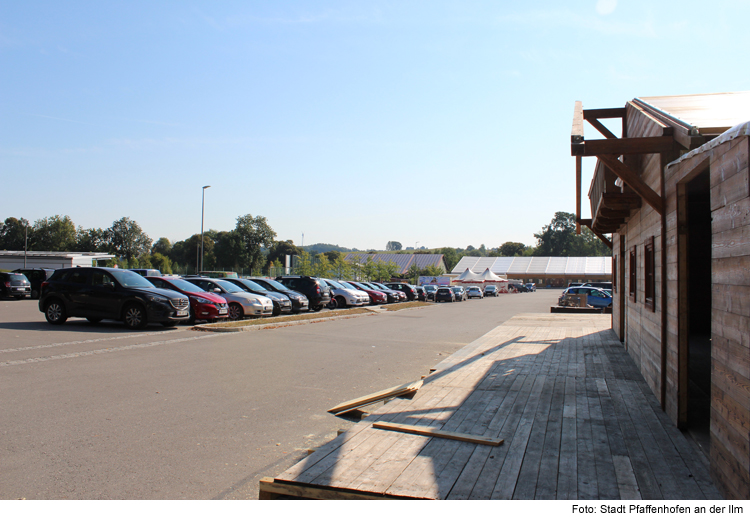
left=570, top=101, right=676, bottom=247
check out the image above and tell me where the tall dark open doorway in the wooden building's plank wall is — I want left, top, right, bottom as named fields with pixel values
left=685, top=171, right=711, bottom=456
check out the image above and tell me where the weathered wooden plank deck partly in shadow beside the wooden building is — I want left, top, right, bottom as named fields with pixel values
left=260, top=314, right=721, bottom=500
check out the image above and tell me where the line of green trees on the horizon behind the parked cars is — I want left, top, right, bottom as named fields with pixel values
left=0, top=212, right=612, bottom=280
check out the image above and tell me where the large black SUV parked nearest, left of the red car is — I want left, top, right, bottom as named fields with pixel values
left=39, top=268, right=190, bottom=329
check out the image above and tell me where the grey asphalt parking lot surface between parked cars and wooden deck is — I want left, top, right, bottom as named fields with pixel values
left=0, top=290, right=559, bottom=499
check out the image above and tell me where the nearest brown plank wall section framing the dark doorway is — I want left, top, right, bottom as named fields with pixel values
left=665, top=137, right=750, bottom=499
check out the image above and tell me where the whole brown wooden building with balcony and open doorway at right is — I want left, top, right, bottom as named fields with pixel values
left=571, top=92, right=750, bottom=499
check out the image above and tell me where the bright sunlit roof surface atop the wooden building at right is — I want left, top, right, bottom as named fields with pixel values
left=636, top=92, right=750, bottom=129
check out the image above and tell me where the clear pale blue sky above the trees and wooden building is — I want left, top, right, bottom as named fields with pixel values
left=0, top=0, right=750, bottom=249
